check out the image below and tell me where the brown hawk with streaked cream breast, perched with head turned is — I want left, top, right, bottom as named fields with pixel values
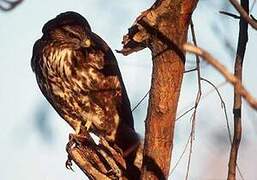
left=31, top=12, right=138, bottom=150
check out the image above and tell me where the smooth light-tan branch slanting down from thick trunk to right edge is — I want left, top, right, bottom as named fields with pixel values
left=183, top=43, right=257, bottom=110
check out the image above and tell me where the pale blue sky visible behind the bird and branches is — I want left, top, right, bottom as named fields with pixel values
left=0, top=0, right=257, bottom=180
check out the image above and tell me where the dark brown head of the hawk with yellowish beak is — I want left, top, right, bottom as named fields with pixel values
left=42, top=11, right=92, bottom=48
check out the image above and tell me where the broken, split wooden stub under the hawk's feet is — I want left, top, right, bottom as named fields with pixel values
left=66, top=134, right=135, bottom=179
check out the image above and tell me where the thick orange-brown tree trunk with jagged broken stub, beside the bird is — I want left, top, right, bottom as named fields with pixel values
left=120, top=0, right=198, bottom=180
